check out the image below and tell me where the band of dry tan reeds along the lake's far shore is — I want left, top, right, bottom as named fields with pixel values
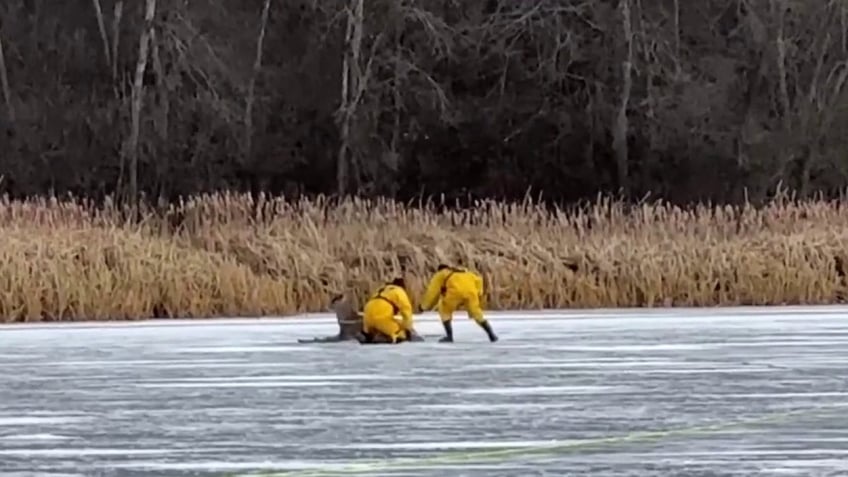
left=0, top=194, right=848, bottom=321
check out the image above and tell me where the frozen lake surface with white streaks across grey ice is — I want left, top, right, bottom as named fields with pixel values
left=0, top=307, right=848, bottom=477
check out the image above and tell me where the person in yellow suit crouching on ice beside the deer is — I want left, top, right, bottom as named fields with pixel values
left=362, top=278, right=421, bottom=344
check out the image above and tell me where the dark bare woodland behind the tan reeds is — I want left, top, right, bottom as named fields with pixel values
left=0, top=0, right=848, bottom=202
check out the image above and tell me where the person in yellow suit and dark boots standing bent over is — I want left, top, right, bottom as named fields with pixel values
left=421, top=264, right=498, bottom=343
